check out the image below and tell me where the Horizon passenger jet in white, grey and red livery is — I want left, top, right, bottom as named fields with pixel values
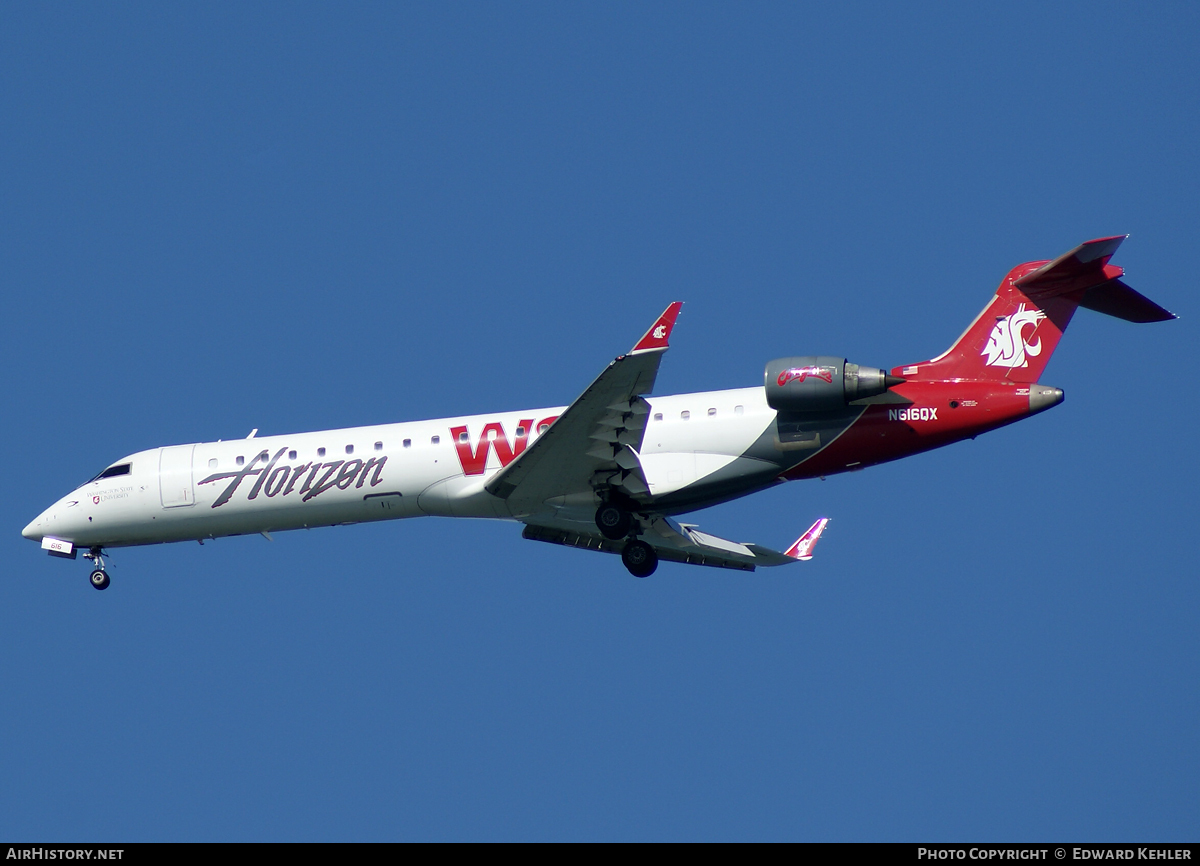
left=22, top=235, right=1176, bottom=589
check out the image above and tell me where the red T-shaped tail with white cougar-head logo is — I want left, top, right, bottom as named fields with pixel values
left=892, top=235, right=1176, bottom=384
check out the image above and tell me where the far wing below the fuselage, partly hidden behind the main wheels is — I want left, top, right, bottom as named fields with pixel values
left=522, top=516, right=829, bottom=571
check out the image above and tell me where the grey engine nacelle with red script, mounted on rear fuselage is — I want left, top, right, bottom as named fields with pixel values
left=763, top=355, right=904, bottom=413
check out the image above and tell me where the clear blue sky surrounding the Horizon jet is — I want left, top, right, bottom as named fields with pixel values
left=0, top=2, right=1200, bottom=841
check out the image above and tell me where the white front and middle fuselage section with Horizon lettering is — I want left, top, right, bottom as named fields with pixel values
left=23, top=387, right=775, bottom=547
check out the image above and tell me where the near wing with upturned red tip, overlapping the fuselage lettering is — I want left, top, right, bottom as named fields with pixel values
left=486, top=301, right=683, bottom=517
